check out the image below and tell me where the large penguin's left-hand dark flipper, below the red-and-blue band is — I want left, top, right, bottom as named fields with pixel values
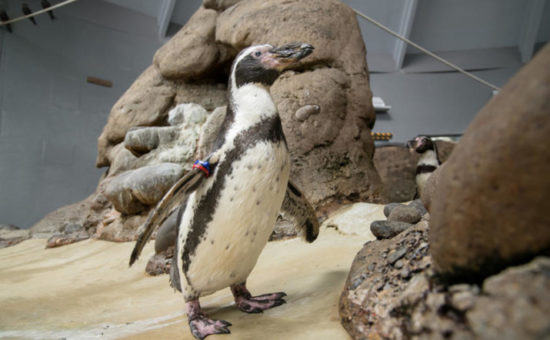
left=130, top=168, right=206, bottom=266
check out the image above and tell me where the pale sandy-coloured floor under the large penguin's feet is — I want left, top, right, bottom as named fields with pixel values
left=0, top=207, right=380, bottom=340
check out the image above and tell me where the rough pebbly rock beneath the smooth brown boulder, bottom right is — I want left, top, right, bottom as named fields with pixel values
left=340, top=221, right=550, bottom=339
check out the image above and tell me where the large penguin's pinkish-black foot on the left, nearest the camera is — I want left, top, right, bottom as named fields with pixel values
left=185, top=299, right=231, bottom=340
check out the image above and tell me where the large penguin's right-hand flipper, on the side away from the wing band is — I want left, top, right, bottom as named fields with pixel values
left=281, top=181, right=319, bottom=242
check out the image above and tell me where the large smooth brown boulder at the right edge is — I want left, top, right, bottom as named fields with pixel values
left=430, top=46, right=550, bottom=278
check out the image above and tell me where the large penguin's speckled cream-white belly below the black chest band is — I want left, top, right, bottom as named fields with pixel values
left=182, top=142, right=290, bottom=295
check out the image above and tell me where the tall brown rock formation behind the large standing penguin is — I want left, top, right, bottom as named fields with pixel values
left=27, top=0, right=382, bottom=241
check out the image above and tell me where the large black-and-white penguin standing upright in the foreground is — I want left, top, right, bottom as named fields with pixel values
left=130, top=43, right=318, bottom=339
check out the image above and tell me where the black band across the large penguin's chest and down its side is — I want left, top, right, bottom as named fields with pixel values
left=181, top=115, right=286, bottom=273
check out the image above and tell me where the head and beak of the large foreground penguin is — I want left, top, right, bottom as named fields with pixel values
left=231, top=43, right=313, bottom=88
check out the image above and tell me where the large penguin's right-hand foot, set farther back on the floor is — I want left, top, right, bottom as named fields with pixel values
left=231, top=283, right=286, bottom=313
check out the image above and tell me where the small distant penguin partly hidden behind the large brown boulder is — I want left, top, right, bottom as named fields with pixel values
left=407, top=136, right=441, bottom=199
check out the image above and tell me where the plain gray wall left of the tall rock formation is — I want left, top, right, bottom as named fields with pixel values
left=0, top=0, right=161, bottom=228
